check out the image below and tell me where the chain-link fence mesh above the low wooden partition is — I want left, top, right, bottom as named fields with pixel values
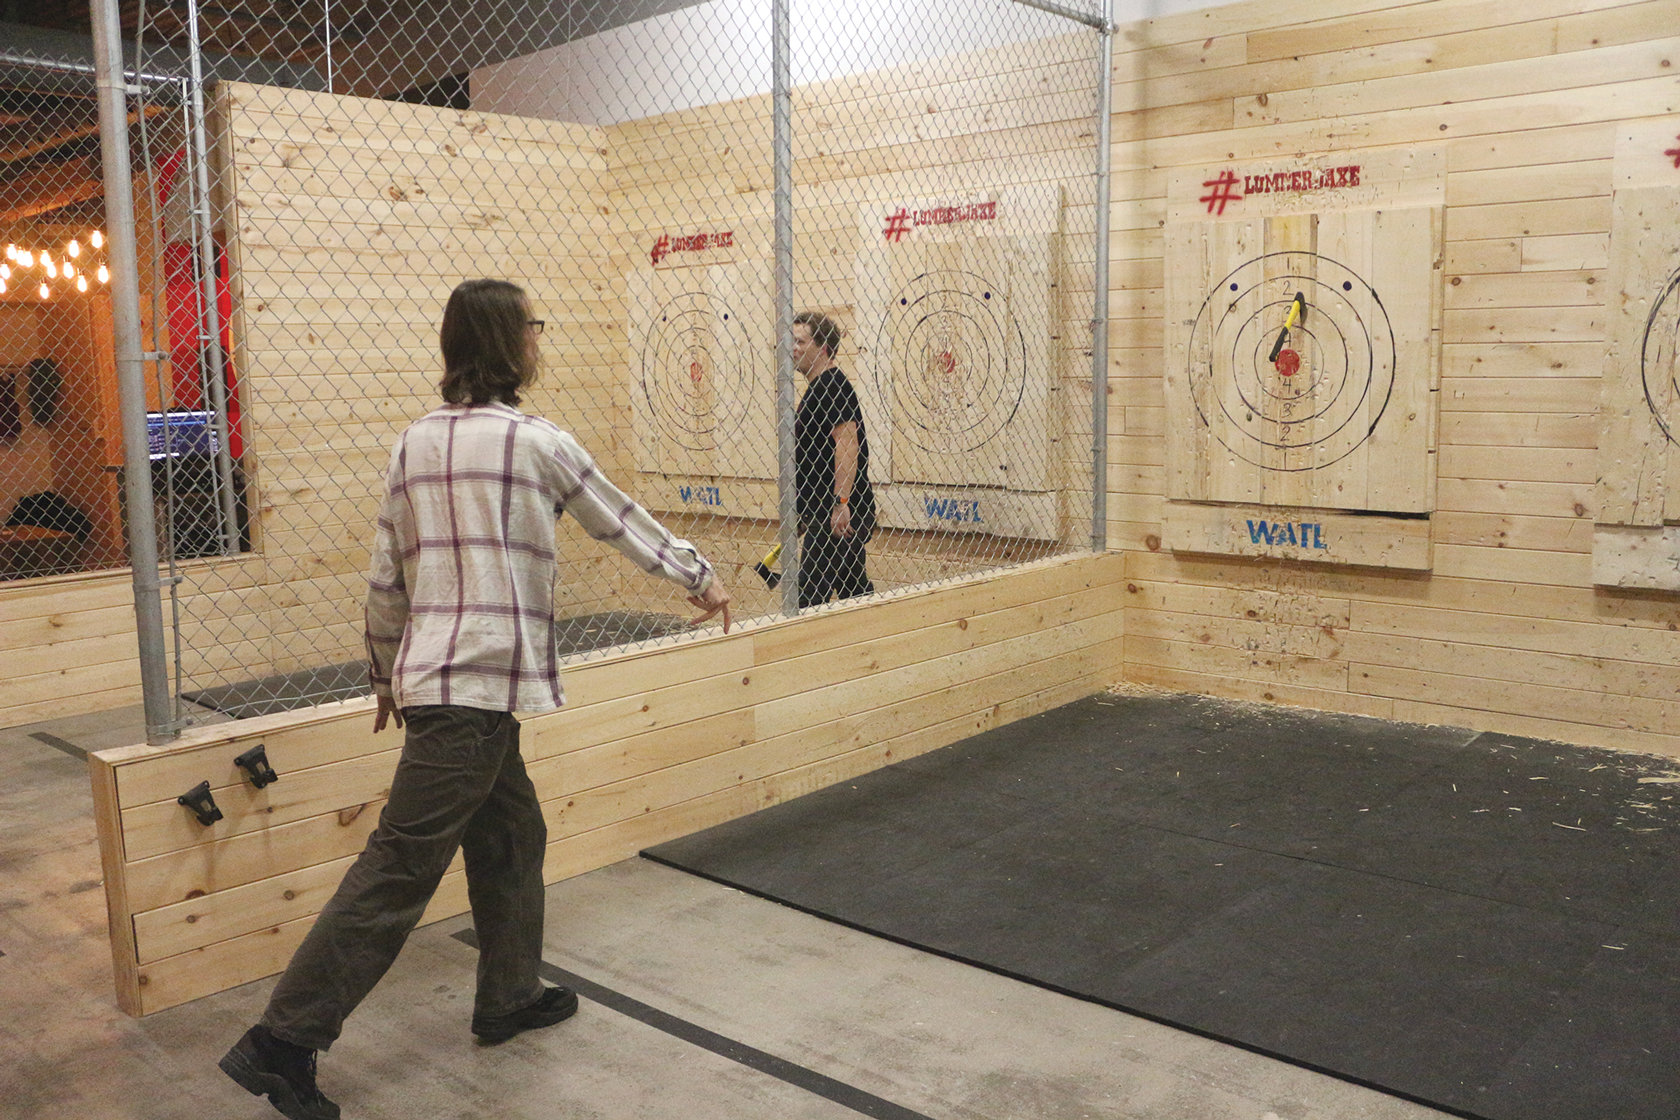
left=13, top=0, right=1100, bottom=722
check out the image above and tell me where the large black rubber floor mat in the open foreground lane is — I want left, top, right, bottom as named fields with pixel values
left=643, top=695, right=1680, bottom=1120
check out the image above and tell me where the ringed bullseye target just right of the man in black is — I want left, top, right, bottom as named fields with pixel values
left=874, top=269, right=1028, bottom=455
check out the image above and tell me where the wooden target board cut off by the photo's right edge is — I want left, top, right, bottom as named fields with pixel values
left=1593, top=118, right=1680, bottom=589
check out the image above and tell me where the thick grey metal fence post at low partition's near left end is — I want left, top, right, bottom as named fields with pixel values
left=92, top=0, right=178, bottom=744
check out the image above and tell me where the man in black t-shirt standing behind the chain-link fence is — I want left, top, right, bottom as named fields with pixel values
left=793, top=311, right=875, bottom=606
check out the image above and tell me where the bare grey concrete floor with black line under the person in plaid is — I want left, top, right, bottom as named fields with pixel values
left=0, top=710, right=1446, bottom=1120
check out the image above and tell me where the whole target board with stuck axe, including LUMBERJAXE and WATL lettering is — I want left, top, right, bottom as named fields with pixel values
left=1164, top=156, right=1443, bottom=568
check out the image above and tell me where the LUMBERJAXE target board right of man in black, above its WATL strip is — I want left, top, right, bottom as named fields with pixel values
left=855, top=185, right=1062, bottom=492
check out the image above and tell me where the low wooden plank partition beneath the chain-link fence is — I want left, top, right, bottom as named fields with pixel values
left=92, top=554, right=1126, bottom=1014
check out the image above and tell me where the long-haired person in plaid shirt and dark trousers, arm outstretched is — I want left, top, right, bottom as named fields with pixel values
left=220, top=280, right=729, bottom=1120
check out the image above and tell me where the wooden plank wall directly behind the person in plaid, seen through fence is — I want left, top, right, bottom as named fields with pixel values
left=162, top=84, right=648, bottom=680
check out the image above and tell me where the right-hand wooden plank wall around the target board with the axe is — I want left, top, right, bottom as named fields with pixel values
left=1107, top=0, right=1680, bottom=754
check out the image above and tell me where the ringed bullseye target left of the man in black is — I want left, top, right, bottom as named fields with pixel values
left=638, top=292, right=751, bottom=452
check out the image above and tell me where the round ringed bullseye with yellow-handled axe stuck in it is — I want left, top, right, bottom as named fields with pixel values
left=1186, top=250, right=1398, bottom=472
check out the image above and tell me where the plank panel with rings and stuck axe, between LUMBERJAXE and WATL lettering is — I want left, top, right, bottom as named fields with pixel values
left=1166, top=210, right=1438, bottom=512
